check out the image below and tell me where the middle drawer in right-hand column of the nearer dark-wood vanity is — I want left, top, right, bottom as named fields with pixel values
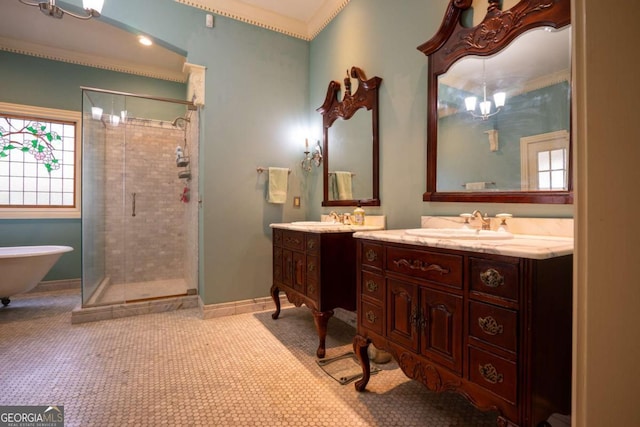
left=469, top=301, right=518, bottom=352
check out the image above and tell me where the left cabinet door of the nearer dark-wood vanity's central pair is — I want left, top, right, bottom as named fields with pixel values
left=387, top=279, right=418, bottom=352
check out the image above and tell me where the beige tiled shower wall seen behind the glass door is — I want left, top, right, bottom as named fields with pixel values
left=105, top=119, right=188, bottom=284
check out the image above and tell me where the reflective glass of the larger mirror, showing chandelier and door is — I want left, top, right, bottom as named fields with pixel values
left=436, top=26, right=571, bottom=192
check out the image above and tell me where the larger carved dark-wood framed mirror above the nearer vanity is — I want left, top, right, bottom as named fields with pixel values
left=418, top=0, right=573, bottom=203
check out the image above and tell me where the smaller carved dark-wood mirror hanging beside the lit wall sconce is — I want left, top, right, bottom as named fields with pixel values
left=316, top=67, right=382, bottom=206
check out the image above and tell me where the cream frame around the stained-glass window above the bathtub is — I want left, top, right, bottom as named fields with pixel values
left=0, top=102, right=82, bottom=219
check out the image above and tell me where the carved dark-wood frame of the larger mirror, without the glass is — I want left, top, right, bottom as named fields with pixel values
left=417, top=0, right=573, bottom=204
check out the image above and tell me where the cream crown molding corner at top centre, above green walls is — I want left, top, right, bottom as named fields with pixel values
left=175, top=0, right=350, bottom=41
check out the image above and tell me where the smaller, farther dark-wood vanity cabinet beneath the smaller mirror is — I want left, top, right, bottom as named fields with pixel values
left=271, top=228, right=356, bottom=358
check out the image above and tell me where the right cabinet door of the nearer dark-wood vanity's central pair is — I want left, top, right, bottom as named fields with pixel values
left=420, top=288, right=463, bottom=373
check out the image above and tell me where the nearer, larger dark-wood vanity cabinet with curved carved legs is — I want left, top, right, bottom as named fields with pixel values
left=354, top=238, right=572, bottom=426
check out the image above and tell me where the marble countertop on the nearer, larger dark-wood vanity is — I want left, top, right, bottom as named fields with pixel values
left=353, top=230, right=573, bottom=259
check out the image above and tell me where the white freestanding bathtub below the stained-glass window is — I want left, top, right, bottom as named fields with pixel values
left=0, top=246, right=73, bottom=306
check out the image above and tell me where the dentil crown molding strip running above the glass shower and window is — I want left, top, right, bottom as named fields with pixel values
left=0, top=37, right=187, bottom=83
